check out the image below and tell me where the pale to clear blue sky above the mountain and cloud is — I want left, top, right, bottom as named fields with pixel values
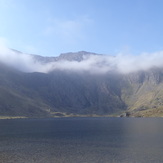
left=0, top=0, right=163, bottom=56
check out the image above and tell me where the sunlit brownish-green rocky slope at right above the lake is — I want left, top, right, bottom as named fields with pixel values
left=122, top=68, right=163, bottom=116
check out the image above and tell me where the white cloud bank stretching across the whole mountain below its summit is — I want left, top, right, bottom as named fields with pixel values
left=0, top=45, right=163, bottom=73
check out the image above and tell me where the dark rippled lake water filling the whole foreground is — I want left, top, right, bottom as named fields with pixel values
left=0, top=118, right=163, bottom=163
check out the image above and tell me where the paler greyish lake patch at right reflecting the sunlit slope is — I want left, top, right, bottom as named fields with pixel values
left=116, top=118, right=163, bottom=163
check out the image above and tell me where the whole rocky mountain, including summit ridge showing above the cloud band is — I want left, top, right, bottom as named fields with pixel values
left=0, top=51, right=163, bottom=117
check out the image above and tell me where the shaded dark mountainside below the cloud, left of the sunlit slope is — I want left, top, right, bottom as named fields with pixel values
left=0, top=62, right=126, bottom=116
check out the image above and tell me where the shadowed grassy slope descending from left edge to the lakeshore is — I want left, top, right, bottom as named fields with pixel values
left=0, top=87, right=51, bottom=117
